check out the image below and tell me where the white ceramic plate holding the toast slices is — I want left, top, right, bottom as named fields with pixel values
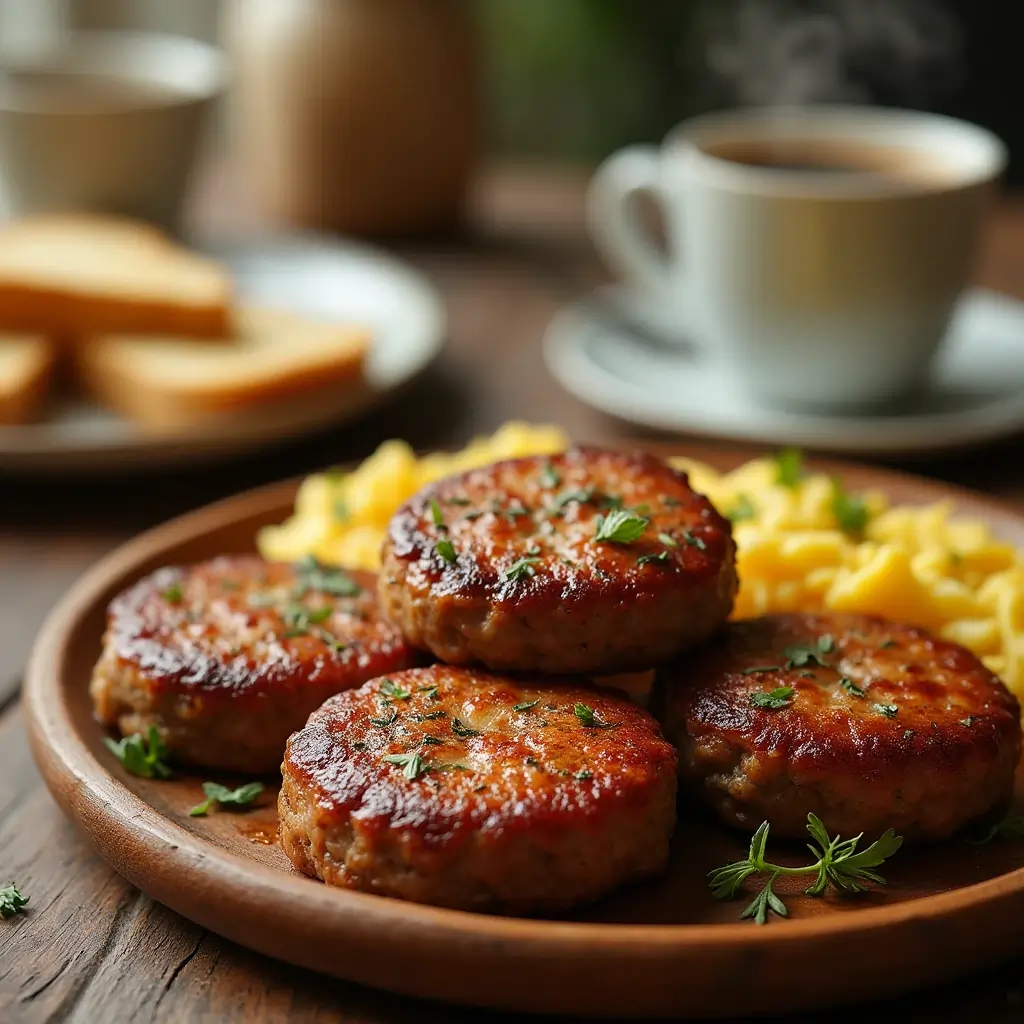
left=0, top=236, right=445, bottom=472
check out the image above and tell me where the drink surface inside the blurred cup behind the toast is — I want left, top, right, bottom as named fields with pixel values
left=0, top=68, right=191, bottom=111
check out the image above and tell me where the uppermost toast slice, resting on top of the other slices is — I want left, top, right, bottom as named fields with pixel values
left=0, top=214, right=232, bottom=340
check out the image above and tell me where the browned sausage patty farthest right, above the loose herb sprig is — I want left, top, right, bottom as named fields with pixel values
left=654, top=614, right=1021, bottom=840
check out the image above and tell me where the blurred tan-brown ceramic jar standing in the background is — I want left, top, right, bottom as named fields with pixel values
left=223, top=0, right=480, bottom=234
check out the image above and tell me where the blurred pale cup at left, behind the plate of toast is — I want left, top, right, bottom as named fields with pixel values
left=0, top=32, right=227, bottom=228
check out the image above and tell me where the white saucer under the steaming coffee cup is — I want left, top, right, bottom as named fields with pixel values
left=545, top=286, right=1024, bottom=455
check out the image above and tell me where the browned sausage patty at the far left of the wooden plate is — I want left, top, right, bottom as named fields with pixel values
left=90, top=557, right=414, bottom=772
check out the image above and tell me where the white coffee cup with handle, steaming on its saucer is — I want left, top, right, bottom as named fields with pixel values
left=589, top=106, right=1007, bottom=408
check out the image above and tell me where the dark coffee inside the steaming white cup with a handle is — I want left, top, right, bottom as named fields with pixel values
left=702, top=139, right=945, bottom=181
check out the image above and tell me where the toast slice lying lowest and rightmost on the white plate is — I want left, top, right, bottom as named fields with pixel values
left=74, top=308, right=370, bottom=431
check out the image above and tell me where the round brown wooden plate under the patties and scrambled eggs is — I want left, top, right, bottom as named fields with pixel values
left=19, top=451, right=1024, bottom=1017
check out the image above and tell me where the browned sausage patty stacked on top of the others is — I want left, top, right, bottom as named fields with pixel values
left=380, top=449, right=736, bottom=674
